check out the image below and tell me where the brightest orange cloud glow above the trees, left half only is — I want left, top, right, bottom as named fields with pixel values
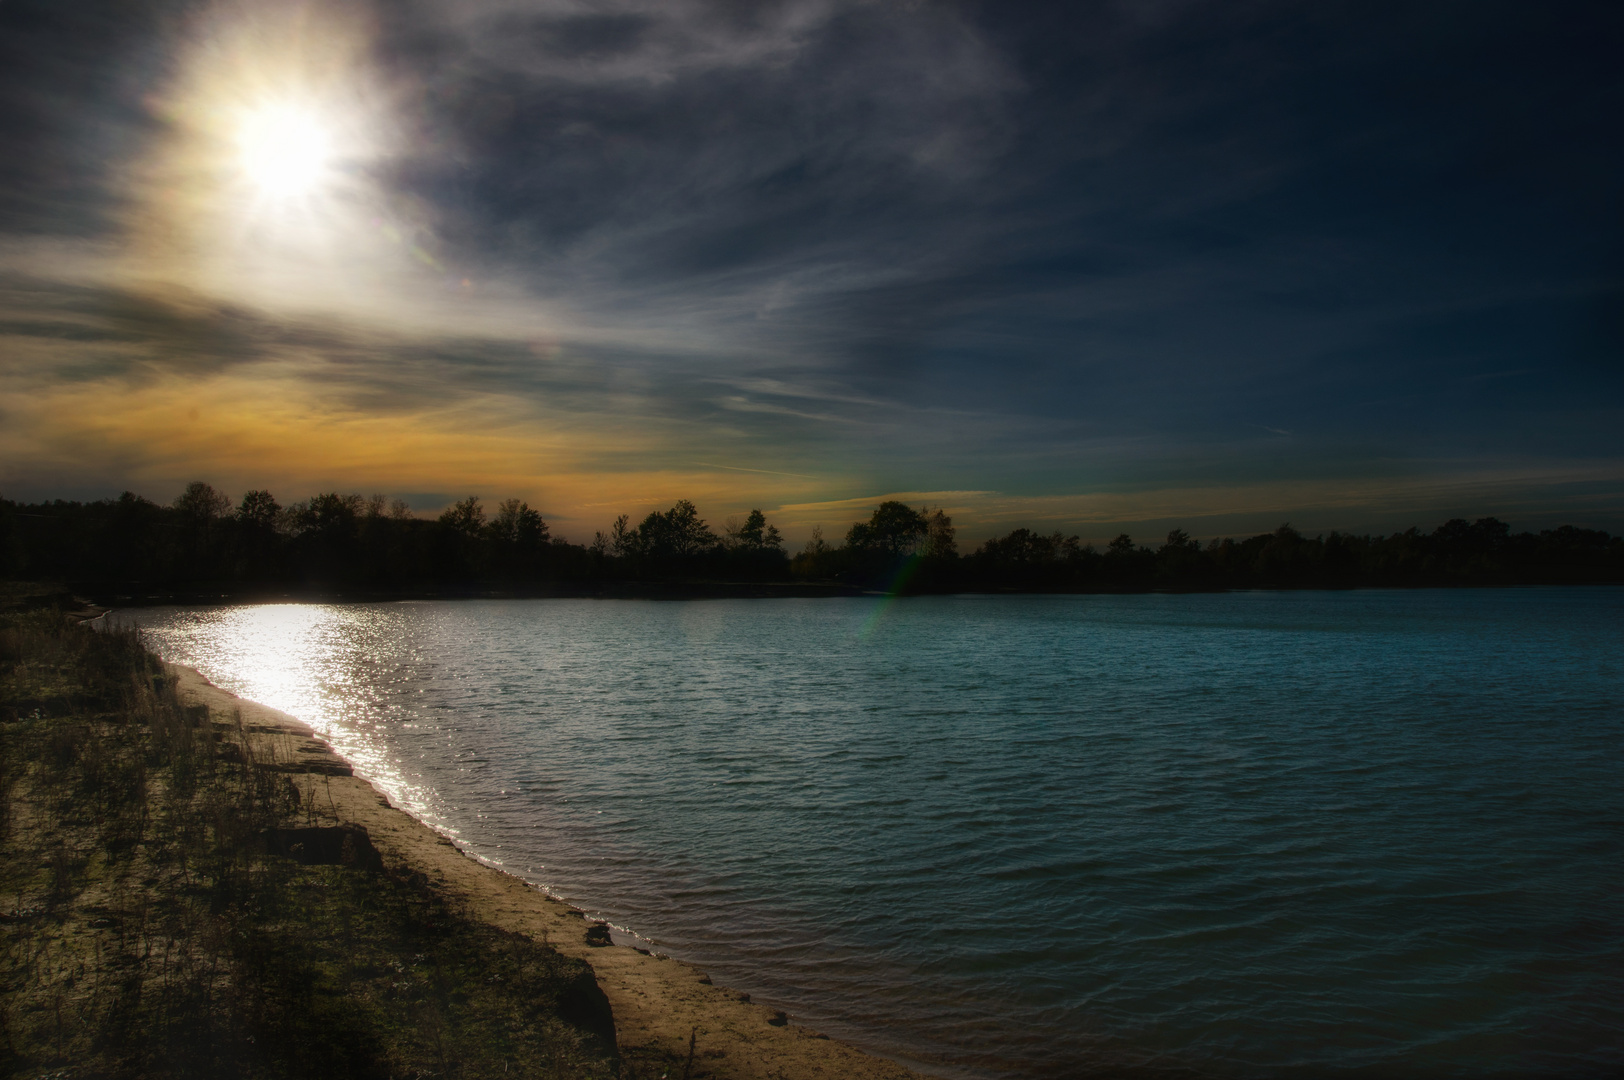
left=0, top=367, right=844, bottom=541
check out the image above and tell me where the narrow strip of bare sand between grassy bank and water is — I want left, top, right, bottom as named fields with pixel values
left=166, top=664, right=924, bottom=1080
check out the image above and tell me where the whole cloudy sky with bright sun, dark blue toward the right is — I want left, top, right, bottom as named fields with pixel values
left=0, top=0, right=1624, bottom=542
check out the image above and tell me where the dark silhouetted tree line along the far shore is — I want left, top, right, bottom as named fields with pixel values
left=0, top=481, right=1624, bottom=596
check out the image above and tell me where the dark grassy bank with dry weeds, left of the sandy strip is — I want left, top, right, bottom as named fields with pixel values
left=0, top=609, right=620, bottom=1080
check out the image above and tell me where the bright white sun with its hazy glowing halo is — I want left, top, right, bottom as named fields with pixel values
left=129, top=7, right=440, bottom=309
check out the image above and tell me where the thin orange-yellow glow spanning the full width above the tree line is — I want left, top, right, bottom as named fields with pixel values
left=9, top=355, right=1616, bottom=549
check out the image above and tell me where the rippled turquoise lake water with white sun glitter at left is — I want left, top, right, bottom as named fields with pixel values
left=122, top=590, right=1624, bottom=1077
